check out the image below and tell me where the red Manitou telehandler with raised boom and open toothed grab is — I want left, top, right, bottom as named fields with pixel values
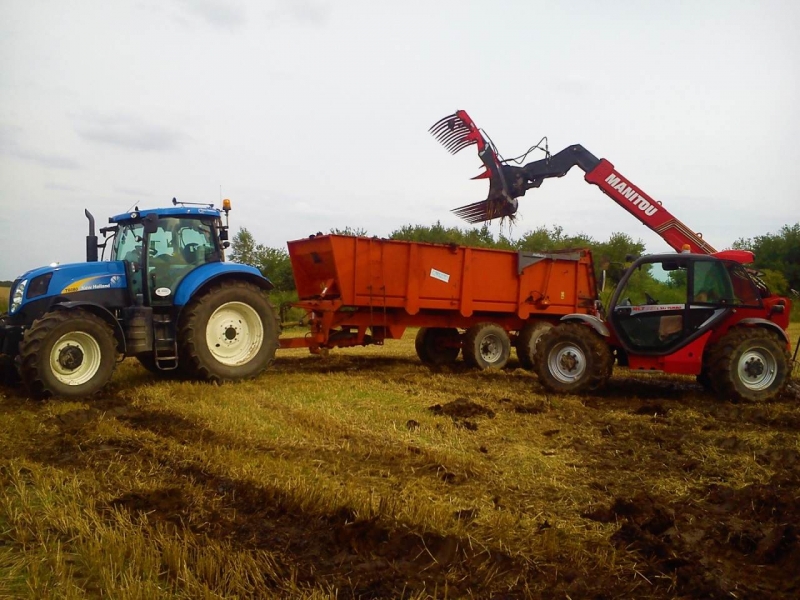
left=430, top=110, right=792, bottom=401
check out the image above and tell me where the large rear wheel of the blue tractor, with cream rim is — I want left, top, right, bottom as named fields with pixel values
left=178, top=281, right=279, bottom=381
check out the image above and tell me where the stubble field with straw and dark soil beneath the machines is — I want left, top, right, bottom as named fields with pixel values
left=0, top=325, right=800, bottom=599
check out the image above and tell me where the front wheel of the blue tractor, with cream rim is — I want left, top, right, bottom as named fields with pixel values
left=19, top=309, right=117, bottom=398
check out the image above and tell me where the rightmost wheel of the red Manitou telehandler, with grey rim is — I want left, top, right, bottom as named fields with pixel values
left=704, top=327, right=792, bottom=402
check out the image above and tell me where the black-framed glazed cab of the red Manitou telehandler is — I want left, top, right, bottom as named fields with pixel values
left=607, top=253, right=763, bottom=355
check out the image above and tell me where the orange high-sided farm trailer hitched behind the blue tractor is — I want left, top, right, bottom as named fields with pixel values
left=280, top=235, right=597, bottom=368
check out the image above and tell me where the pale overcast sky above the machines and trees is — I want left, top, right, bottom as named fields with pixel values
left=0, top=0, right=800, bottom=279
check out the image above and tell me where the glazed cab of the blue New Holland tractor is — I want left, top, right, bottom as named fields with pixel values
left=108, top=207, right=227, bottom=307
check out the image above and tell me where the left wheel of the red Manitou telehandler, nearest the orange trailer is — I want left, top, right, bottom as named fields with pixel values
left=534, top=323, right=614, bottom=393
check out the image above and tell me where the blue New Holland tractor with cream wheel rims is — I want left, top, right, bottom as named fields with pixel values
left=0, top=199, right=279, bottom=397
